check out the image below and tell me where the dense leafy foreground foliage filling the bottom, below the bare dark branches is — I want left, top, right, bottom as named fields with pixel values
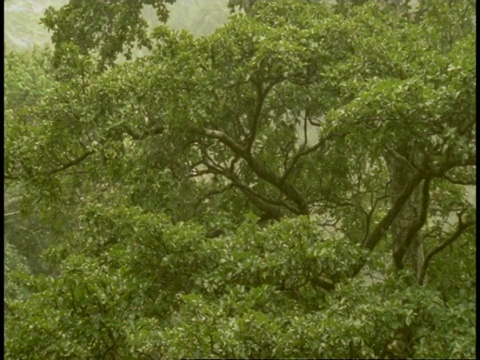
left=6, top=210, right=474, bottom=358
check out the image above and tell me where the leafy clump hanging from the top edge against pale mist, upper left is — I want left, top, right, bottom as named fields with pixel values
left=41, top=0, right=175, bottom=71
